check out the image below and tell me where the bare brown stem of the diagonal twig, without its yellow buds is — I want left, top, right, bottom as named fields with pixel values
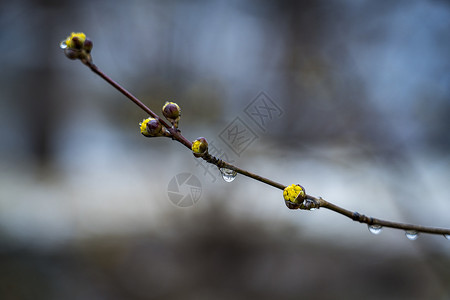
left=75, top=60, right=450, bottom=237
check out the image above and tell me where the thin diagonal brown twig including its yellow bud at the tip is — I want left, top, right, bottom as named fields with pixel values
left=61, top=33, right=450, bottom=239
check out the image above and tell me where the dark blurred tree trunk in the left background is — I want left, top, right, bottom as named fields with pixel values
left=21, top=0, right=65, bottom=167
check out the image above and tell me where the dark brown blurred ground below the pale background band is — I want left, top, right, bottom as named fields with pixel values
left=0, top=206, right=450, bottom=299
